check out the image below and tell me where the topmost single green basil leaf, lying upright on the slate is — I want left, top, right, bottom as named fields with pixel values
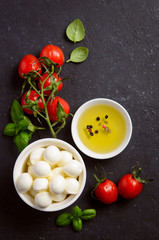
left=66, top=18, right=85, bottom=43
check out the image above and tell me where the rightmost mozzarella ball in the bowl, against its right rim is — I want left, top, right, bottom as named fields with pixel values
left=63, top=160, right=83, bottom=177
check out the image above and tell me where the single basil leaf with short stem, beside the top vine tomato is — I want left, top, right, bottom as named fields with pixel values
left=66, top=47, right=89, bottom=63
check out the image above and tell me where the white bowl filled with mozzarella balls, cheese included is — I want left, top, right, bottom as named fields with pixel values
left=13, top=138, right=86, bottom=212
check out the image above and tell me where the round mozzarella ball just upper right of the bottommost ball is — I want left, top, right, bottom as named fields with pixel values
left=49, top=175, right=66, bottom=194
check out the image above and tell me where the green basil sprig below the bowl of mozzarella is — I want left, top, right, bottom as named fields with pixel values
left=56, top=206, right=96, bottom=232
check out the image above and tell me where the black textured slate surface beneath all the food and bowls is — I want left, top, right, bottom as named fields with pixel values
left=0, top=0, right=159, bottom=240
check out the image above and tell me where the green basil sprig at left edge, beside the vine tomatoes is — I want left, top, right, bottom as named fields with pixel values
left=3, top=99, right=44, bottom=152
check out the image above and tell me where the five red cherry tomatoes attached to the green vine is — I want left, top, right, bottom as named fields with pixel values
left=18, top=44, right=70, bottom=122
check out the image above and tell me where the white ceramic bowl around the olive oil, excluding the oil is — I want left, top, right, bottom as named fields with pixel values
left=71, top=98, right=132, bottom=159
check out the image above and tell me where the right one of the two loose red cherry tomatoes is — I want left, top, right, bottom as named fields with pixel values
left=118, top=173, right=143, bottom=199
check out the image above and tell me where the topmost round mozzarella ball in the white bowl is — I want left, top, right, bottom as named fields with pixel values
left=44, top=146, right=61, bottom=165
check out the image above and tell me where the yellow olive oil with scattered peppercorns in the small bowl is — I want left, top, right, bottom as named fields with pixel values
left=77, top=104, right=126, bottom=153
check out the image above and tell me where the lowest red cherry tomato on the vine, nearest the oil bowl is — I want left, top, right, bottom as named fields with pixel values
left=47, top=97, right=70, bottom=122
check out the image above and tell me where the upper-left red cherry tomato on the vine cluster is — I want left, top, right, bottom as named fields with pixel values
left=18, top=54, right=42, bottom=79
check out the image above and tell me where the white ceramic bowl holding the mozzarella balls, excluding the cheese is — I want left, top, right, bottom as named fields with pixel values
left=13, top=138, right=86, bottom=212
